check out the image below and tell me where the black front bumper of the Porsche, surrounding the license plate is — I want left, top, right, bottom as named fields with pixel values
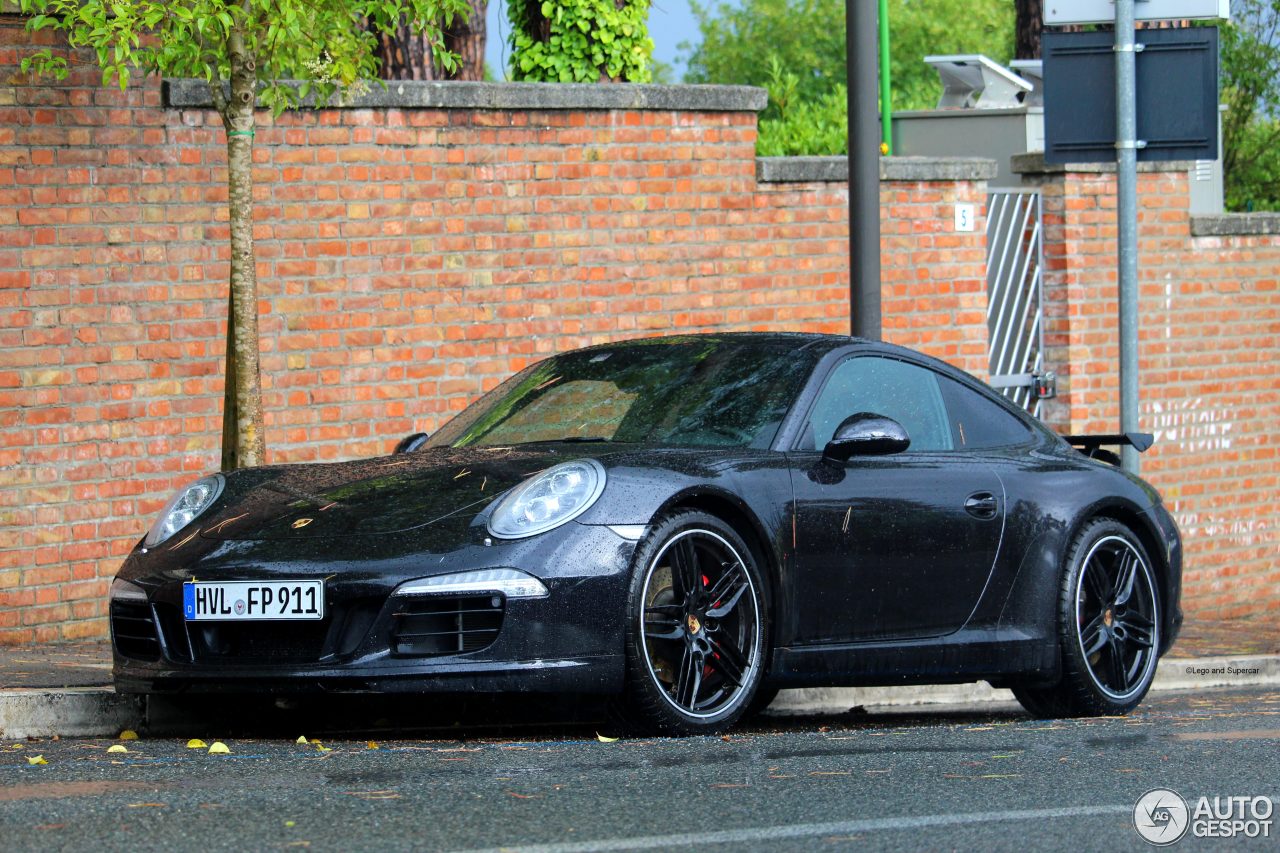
left=111, top=525, right=634, bottom=694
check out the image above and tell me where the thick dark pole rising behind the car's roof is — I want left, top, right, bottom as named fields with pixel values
left=845, top=0, right=881, bottom=341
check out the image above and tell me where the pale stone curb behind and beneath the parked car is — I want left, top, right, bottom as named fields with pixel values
left=0, top=654, right=1280, bottom=739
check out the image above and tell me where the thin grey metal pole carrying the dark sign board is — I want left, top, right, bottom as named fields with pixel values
left=1115, top=0, right=1142, bottom=474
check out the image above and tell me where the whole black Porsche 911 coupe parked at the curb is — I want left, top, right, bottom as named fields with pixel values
left=110, top=334, right=1181, bottom=734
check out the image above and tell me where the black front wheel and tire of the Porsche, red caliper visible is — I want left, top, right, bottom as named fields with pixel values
left=617, top=511, right=769, bottom=736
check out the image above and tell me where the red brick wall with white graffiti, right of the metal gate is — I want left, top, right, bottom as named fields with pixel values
left=1037, top=162, right=1280, bottom=617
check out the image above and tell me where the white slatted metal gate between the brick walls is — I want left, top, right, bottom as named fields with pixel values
left=987, top=190, right=1053, bottom=415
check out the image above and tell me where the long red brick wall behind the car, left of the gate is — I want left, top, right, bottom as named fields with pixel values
left=0, top=28, right=986, bottom=643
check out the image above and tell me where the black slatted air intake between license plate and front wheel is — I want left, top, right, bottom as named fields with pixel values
left=392, top=593, right=506, bottom=657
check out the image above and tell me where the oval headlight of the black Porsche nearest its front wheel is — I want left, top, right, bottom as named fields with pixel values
left=488, top=459, right=604, bottom=539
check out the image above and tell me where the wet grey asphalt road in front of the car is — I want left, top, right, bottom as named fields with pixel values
left=0, top=690, right=1280, bottom=853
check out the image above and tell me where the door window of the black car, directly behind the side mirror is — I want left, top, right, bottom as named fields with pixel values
left=800, top=356, right=952, bottom=452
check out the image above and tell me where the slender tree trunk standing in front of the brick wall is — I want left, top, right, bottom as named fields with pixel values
left=211, top=31, right=266, bottom=467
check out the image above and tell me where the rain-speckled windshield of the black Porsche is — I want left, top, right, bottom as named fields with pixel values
left=429, top=338, right=814, bottom=448
